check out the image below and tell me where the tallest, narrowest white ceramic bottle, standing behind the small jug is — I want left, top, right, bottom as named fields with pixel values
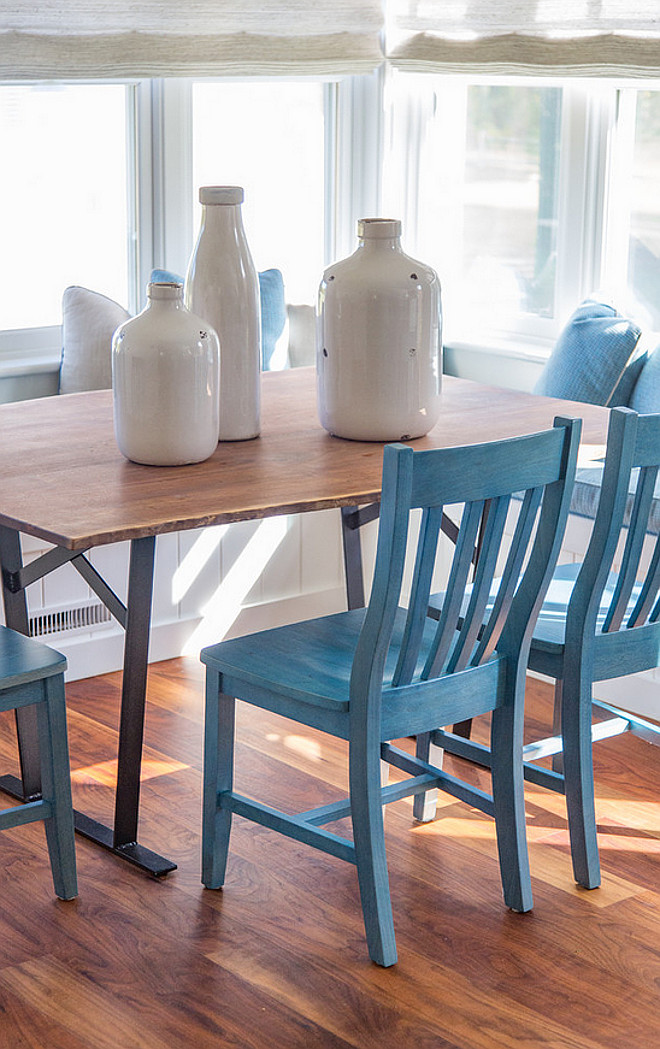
left=185, top=186, right=261, bottom=441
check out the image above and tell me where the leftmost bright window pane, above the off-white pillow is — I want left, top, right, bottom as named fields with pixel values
left=0, top=84, right=132, bottom=329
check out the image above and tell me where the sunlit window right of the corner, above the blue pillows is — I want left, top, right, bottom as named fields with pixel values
left=385, top=72, right=660, bottom=345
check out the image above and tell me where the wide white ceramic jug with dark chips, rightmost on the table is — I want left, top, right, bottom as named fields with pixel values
left=317, top=218, right=442, bottom=441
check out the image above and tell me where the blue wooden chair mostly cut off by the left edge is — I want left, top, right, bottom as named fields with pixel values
left=0, top=626, right=78, bottom=900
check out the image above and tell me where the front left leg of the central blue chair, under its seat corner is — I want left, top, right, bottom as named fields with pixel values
left=201, top=668, right=236, bottom=889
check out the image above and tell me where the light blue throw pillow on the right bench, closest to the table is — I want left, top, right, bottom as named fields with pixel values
left=534, top=299, right=641, bottom=405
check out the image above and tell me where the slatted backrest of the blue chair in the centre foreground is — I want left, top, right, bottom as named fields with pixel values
left=350, top=420, right=580, bottom=721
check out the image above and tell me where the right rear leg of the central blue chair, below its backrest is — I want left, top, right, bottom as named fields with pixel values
left=491, top=703, right=533, bottom=912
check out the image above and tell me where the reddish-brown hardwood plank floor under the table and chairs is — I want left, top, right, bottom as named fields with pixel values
left=0, top=660, right=660, bottom=1049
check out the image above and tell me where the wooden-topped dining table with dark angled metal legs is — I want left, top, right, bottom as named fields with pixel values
left=0, top=368, right=609, bottom=875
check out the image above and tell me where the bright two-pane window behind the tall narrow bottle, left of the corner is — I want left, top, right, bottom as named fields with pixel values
left=0, top=78, right=334, bottom=363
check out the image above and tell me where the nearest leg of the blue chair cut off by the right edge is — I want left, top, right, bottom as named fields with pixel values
left=561, top=671, right=600, bottom=889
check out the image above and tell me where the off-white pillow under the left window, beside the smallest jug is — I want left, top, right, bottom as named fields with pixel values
left=60, top=286, right=130, bottom=393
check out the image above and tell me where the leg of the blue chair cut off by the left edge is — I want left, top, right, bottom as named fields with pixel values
left=37, top=675, right=78, bottom=900
